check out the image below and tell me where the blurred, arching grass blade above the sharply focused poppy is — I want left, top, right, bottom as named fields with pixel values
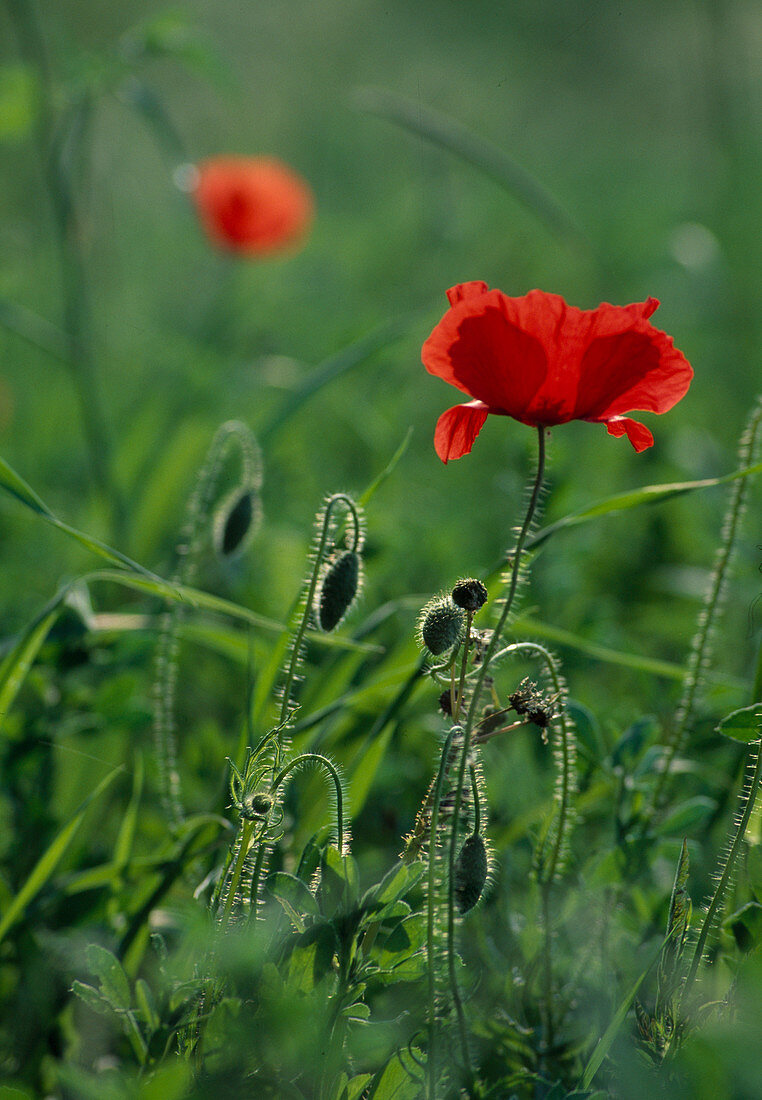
left=355, top=88, right=587, bottom=244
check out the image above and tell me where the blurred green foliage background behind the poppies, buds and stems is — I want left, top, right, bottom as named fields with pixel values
left=0, top=0, right=762, bottom=1100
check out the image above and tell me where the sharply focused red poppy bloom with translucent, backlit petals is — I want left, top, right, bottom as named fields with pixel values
left=421, top=283, right=693, bottom=462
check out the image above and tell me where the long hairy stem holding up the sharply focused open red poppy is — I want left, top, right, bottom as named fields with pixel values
left=442, top=427, right=545, bottom=1075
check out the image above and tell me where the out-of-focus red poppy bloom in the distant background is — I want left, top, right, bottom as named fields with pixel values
left=194, top=156, right=313, bottom=256
